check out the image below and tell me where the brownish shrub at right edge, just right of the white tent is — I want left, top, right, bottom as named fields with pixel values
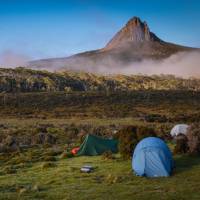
left=187, top=124, right=200, bottom=154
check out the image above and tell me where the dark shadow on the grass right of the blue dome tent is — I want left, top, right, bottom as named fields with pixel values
left=173, top=155, right=200, bottom=174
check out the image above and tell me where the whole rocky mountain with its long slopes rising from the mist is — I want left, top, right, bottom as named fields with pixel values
left=29, top=17, right=195, bottom=72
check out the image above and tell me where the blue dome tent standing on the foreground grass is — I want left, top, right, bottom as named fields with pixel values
left=132, top=137, right=173, bottom=177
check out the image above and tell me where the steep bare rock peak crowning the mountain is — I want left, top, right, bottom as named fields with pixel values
left=104, top=17, right=160, bottom=49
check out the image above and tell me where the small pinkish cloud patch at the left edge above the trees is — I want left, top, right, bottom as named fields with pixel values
left=0, top=50, right=31, bottom=67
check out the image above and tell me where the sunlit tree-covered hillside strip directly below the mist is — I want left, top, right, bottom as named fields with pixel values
left=0, top=68, right=200, bottom=92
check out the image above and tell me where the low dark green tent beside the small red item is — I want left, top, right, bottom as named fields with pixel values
left=77, top=135, right=118, bottom=156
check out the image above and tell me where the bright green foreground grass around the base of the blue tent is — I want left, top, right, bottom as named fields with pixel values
left=0, top=149, right=200, bottom=200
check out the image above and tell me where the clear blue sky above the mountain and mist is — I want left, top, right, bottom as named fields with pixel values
left=0, top=0, right=200, bottom=59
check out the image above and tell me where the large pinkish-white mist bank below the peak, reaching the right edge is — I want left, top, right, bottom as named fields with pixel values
left=71, top=51, right=200, bottom=78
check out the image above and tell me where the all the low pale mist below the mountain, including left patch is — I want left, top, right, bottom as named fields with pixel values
left=0, top=51, right=200, bottom=78
